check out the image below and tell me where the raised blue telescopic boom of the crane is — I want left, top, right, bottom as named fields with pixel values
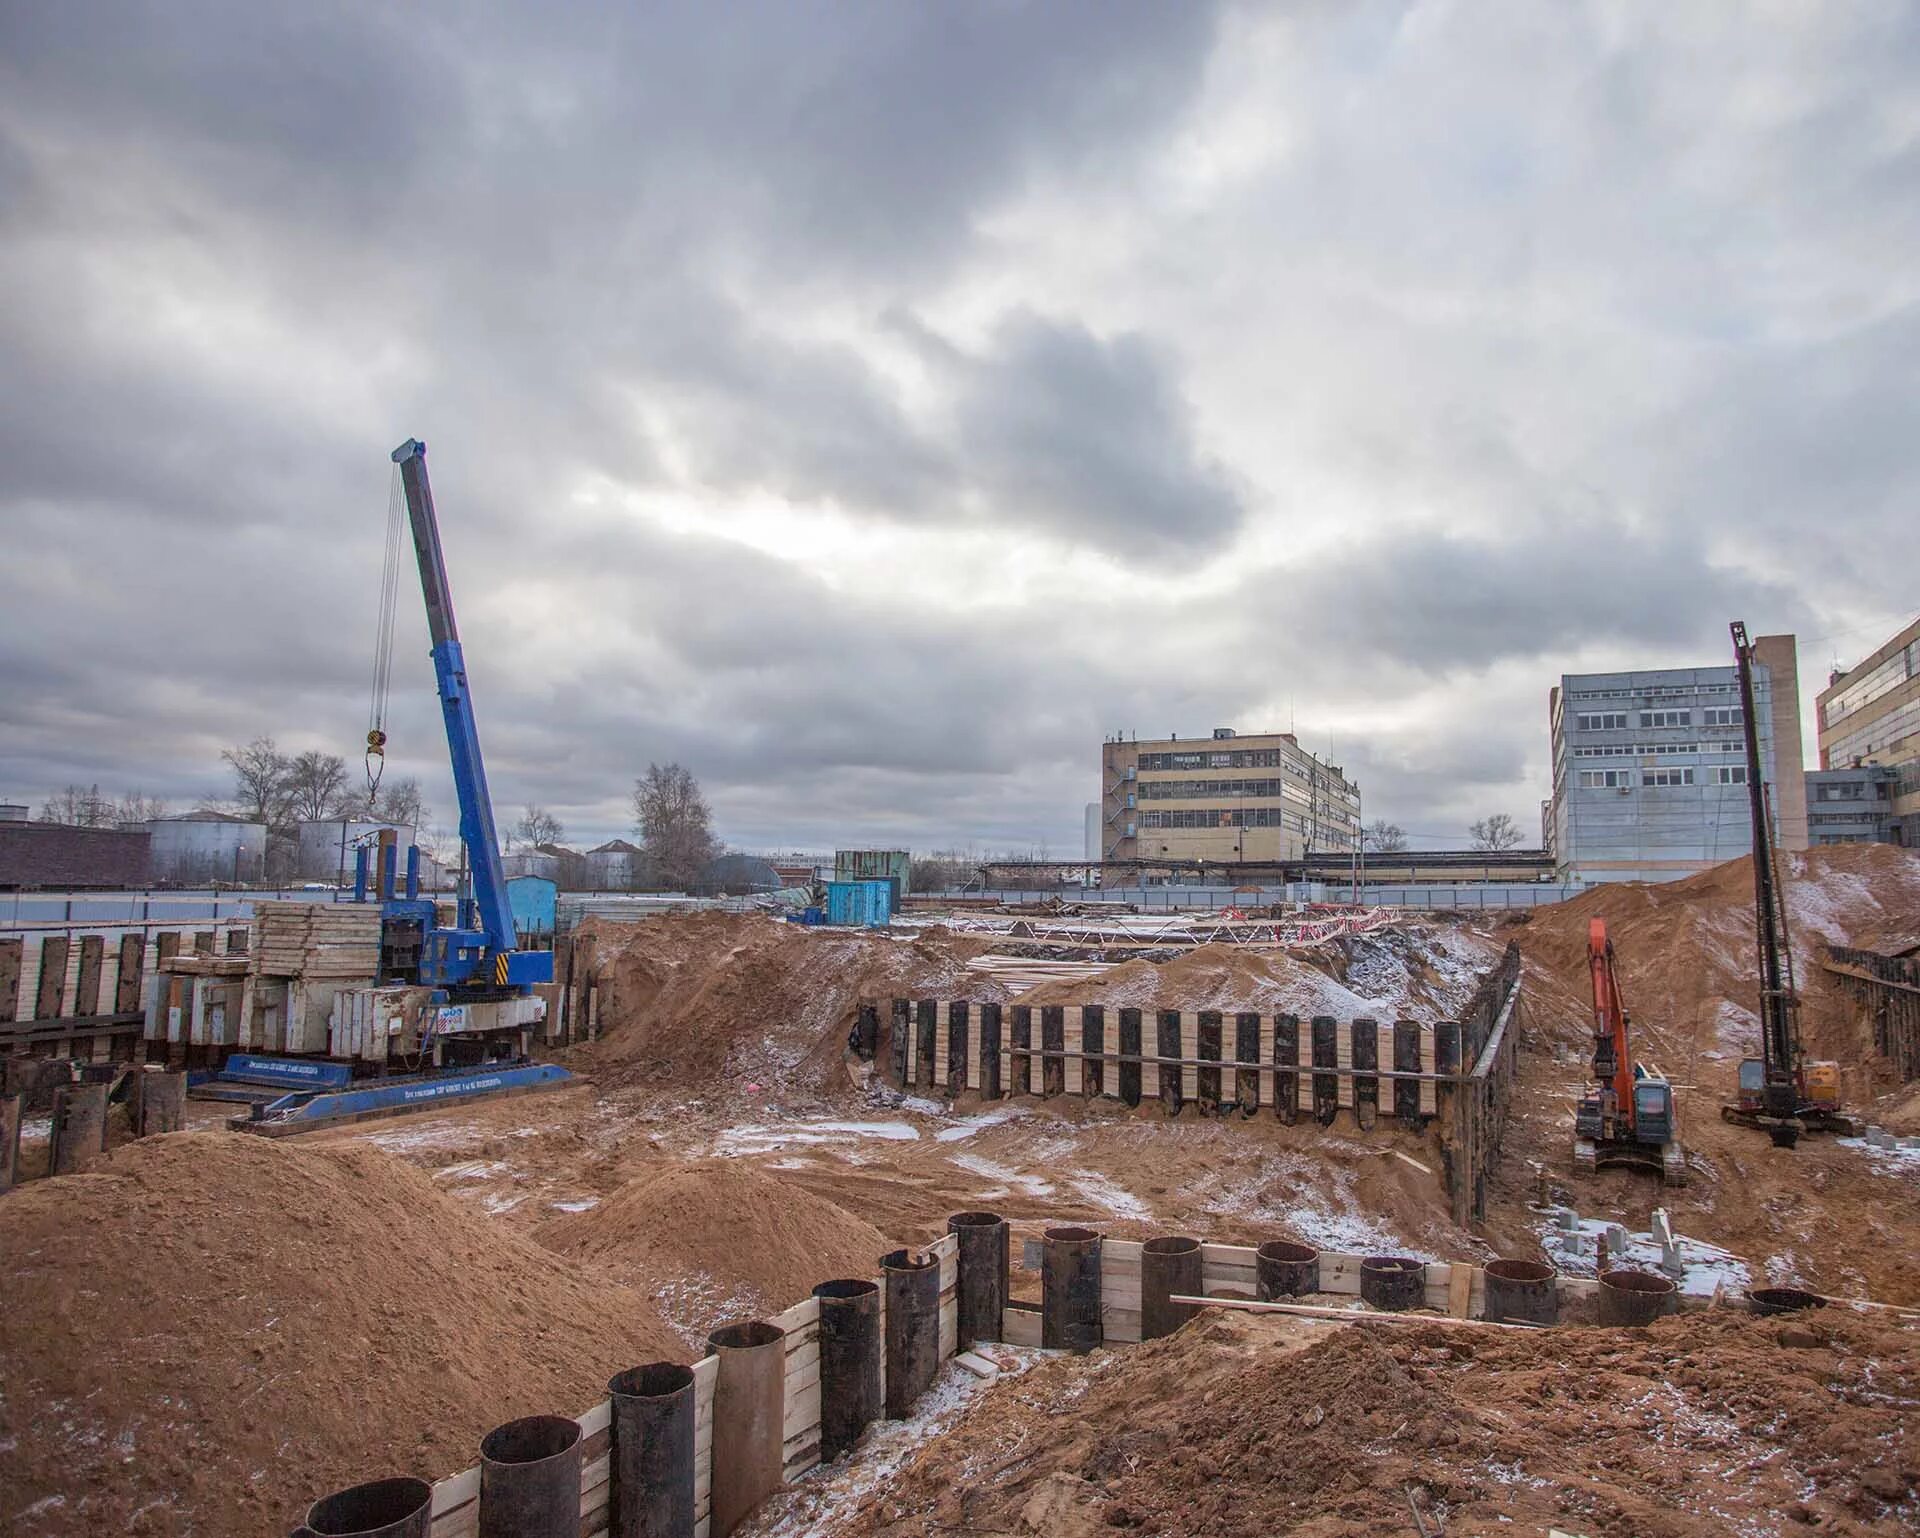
left=394, top=438, right=533, bottom=985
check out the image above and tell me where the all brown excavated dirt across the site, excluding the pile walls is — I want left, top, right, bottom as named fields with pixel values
left=0, top=847, right=1920, bottom=1538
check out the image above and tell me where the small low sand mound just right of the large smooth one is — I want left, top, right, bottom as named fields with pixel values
left=540, top=1160, right=893, bottom=1346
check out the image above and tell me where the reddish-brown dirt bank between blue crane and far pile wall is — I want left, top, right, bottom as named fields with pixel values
left=578, top=914, right=1008, bottom=1102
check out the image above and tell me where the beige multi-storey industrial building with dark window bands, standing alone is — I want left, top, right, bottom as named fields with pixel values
left=1100, top=726, right=1359, bottom=866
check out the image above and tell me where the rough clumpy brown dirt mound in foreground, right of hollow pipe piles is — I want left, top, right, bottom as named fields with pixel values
left=835, top=1310, right=1920, bottom=1538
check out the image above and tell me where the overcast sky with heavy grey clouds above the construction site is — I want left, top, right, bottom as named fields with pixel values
left=0, top=0, right=1920, bottom=854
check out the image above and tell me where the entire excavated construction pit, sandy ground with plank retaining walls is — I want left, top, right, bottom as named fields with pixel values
left=0, top=847, right=1920, bottom=1538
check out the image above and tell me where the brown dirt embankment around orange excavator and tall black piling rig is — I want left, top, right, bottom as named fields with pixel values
left=1490, top=845, right=1920, bottom=1304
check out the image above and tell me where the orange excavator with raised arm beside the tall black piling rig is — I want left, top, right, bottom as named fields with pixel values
left=1572, top=918, right=1686, bottom=1185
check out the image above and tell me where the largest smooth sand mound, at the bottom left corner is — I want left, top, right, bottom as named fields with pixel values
left=0, top=1133, right=682, bottom=1538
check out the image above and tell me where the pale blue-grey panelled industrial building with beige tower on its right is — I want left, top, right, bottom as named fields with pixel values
left=1548, top=636, right=1807, bottom=881
